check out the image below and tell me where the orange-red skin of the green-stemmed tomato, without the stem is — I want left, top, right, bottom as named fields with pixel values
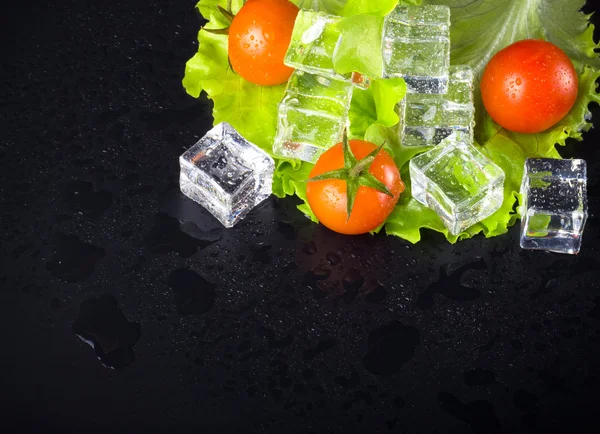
left=306, top=140, right=404, bottom=235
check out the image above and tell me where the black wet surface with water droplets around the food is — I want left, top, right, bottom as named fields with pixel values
left=0, top=0, right=600, bottom=433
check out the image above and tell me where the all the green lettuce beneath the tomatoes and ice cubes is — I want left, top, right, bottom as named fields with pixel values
left=183, top=0, right=600, bottom=243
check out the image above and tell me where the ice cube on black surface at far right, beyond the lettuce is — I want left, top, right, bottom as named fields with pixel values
left=521, top=158, right=588, bottom=254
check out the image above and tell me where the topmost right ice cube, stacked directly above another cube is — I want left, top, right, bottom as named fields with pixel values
left=382, top=5, right=450, bottom=94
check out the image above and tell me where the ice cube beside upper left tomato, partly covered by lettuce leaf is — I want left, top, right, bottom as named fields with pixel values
left=284, top=9, right=370, bottom=88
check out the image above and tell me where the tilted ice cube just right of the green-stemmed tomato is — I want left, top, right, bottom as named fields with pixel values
left=409, top=132, right=504, bottom=235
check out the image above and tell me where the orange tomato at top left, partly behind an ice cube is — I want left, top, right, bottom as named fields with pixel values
left=229, top=0, right=299, bottom=86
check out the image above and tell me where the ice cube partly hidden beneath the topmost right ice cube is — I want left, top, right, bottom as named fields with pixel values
left=399, top=65, right=475, bottom=146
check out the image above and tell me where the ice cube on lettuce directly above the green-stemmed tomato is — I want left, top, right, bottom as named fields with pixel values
left=273, top=70, right=353, bottom=163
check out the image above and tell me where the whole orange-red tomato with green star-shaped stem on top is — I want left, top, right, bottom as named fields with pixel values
left=306, top=133, right=404, bottom=235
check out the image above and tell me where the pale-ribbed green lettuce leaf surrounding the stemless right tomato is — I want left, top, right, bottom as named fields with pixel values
left=423, top=0, right=600, bottom=147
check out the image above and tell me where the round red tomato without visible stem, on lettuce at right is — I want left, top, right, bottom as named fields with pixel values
left=481, top=39, right=578, bottom=133
